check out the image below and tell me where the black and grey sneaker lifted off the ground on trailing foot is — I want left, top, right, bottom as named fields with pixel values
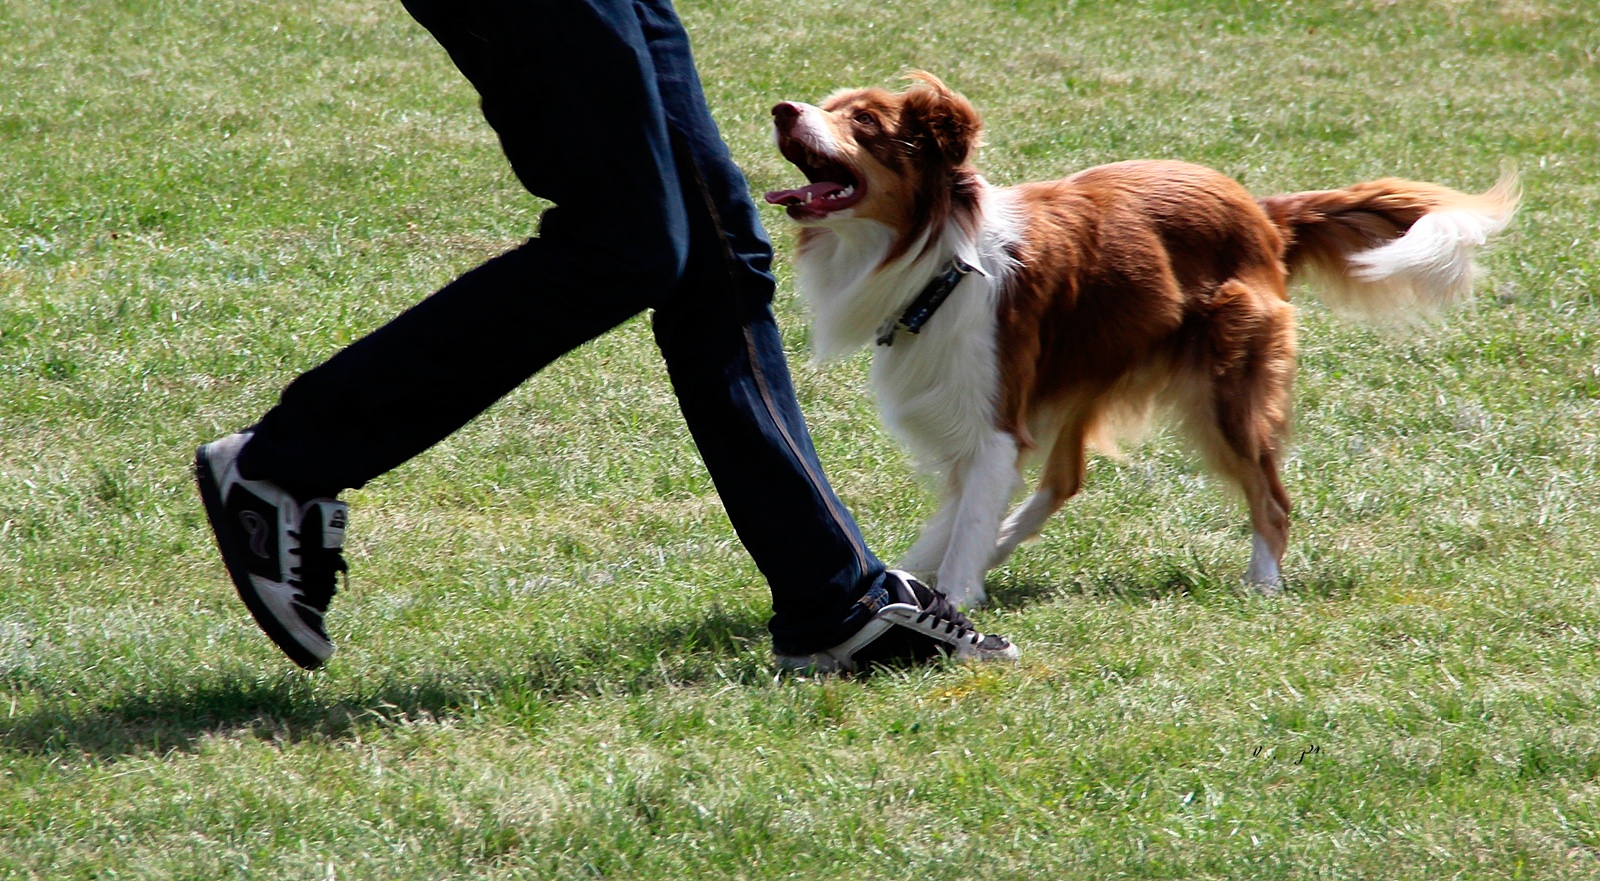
left=195, top=432, right=349, bottom=670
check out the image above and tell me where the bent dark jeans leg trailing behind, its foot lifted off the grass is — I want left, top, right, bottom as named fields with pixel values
left=240, top=0, right=688, bottom=494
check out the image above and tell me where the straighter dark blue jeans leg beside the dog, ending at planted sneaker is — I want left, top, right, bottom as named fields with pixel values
left=638, top=0, right=883, bottom=654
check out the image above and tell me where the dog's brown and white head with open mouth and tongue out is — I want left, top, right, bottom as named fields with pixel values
left=766, top=70, right=981, bottom=251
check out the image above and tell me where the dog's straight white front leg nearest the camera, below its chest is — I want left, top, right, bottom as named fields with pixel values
left=939, top=432, right=1019, bottom=608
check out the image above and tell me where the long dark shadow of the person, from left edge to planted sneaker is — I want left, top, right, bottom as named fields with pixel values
left=0, top=608, right=770, bottom=759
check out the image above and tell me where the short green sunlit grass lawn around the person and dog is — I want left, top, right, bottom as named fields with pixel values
left=0, top=0, right=1600, bottom=879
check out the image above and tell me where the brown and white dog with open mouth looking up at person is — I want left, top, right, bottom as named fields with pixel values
left=766, top=72, right=1517, bottom=606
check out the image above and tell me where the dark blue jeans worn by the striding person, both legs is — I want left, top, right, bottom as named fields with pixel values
left=240, top=0, right=883, bottom=652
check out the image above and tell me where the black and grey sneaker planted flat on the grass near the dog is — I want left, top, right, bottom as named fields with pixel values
left=778, top=569, right=1018, bottom=673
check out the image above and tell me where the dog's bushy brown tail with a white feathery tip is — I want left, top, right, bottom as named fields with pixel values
left=1259, top=166, right=1522, bottom=318
